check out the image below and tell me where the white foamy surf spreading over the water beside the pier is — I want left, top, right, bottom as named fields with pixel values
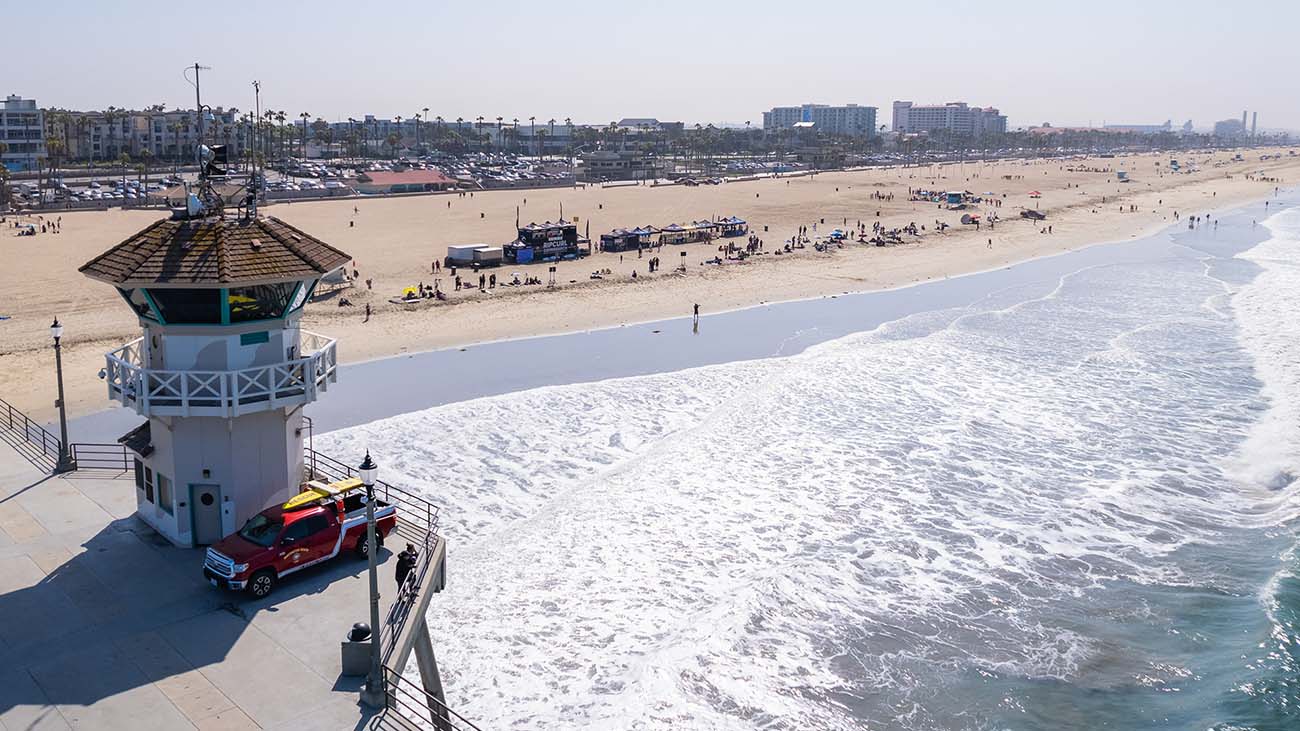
left=317, top=201, right=1300, bottom=728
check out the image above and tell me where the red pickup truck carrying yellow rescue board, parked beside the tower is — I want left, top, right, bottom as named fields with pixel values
left=203, top=479, right=398, bottom=598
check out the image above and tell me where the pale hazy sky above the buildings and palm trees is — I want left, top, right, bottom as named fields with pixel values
left=10, top=0, right=1300, bottom=129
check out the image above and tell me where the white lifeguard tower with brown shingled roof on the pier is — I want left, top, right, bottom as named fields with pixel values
left=81, top=209, right=351, bottom=546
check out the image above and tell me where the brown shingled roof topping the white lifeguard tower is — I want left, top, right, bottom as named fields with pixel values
left=79, top=217, right=351, bottom=286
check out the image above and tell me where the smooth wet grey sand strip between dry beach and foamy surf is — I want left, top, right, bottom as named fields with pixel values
left=63, top=189, right=1300, bottom=440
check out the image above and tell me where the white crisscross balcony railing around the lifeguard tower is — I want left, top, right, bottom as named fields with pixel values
left=104, top=332, right=338, bottom=418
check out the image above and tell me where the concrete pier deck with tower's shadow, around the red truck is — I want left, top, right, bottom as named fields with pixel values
left=0, top=445, right=393, bottom=731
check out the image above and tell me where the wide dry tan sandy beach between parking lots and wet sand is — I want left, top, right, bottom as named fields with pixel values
left=0, top=151, right=1300, bottom=419
